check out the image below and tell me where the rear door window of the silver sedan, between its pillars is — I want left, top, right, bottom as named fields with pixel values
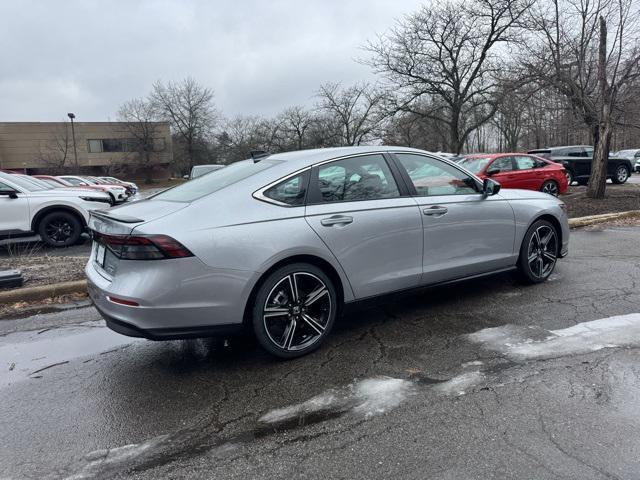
left=318, top=155, right=400, bottom=202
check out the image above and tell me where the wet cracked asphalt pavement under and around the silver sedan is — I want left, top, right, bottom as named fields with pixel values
left=0, top=228, right=640, bottom=479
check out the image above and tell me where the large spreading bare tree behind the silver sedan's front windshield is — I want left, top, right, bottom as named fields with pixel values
left=366, top=0, right=534, bottom=153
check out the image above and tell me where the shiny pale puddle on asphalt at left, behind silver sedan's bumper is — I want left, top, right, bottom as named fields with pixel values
left=0, top=322, right=139, bottom=388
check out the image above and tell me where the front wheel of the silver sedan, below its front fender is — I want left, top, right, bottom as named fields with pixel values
left=518, top=220, right=560, bottom=283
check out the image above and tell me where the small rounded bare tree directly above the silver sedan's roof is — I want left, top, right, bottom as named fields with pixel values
left=317, top=83, right=386, bottom=145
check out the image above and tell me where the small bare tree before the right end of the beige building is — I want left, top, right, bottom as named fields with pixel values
left=114, top=98, right=166, bottom=183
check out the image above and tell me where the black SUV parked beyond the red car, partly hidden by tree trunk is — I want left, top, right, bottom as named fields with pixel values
left=528, top=145, right=633, bottom=185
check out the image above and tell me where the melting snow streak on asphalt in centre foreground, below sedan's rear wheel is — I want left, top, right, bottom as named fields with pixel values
left=258, top=377, right=413, bottom=424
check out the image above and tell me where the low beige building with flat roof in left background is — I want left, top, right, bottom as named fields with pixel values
left=0, top=122, right=172, bottom=174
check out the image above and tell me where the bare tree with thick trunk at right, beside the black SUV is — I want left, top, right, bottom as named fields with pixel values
left=523, top=0, right=640, bottom=198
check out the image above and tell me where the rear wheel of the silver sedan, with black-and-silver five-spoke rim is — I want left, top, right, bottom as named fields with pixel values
left=252, top=263, right=338, bottom=359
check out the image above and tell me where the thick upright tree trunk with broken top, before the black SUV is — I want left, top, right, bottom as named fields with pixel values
left=587, top=17, right=612, bottom=199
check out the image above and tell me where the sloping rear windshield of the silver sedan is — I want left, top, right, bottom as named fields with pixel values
left=152, top=160, right=280, bottom=202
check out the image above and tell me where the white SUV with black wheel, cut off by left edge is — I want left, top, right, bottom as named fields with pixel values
left=0, top=172, right=111, bottom=247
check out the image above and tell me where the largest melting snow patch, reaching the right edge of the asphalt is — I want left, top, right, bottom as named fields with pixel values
left=467, top=313, right=640, bottom=360
